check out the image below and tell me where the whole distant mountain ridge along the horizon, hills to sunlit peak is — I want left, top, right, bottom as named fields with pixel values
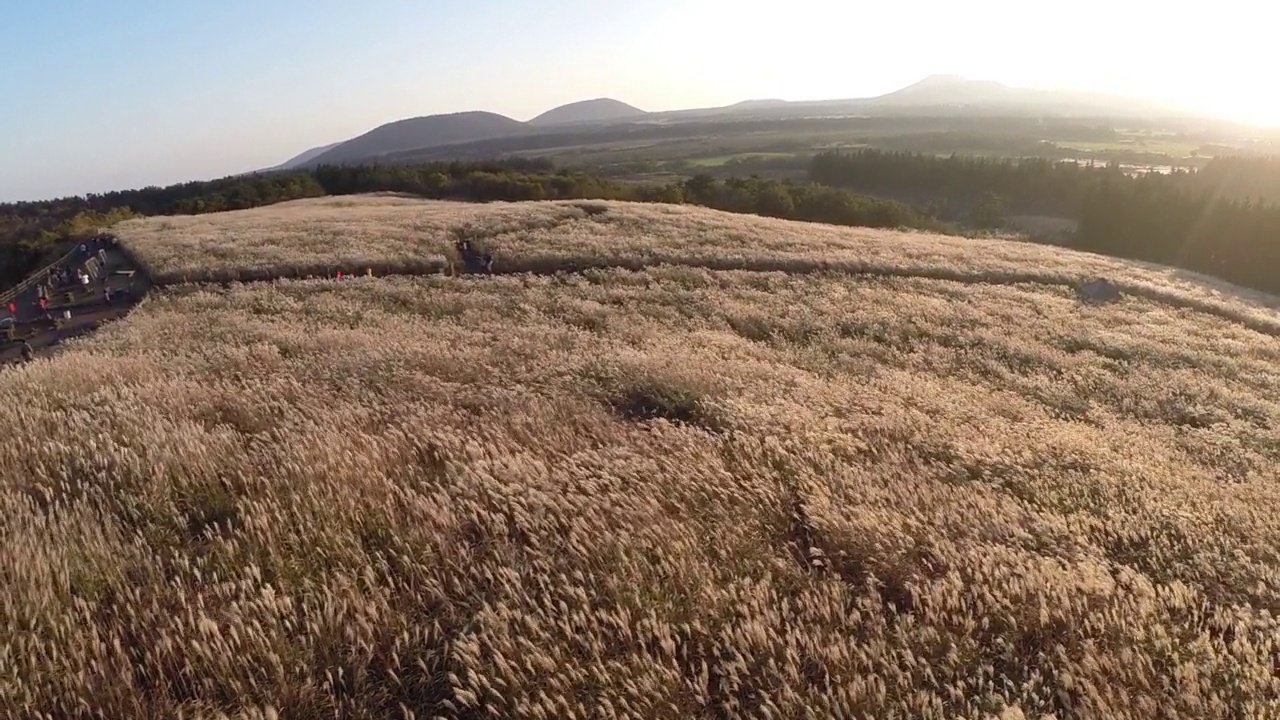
left=271, top=74, right=1194, bottom=169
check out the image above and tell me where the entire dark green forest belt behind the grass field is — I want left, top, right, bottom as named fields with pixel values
left=0, top=150, right=1280, bottom=292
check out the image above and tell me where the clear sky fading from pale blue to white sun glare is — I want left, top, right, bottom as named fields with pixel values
left=0, top=0, right=1280, bottom=201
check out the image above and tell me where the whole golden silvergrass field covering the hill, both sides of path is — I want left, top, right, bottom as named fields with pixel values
left=0, top=199, right=1280, bottom=719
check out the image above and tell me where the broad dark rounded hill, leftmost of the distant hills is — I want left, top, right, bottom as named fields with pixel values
left=305, top=110, right=529, bottom=167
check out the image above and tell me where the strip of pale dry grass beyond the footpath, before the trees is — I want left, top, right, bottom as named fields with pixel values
left=116, top=195, right=1280, bottom=334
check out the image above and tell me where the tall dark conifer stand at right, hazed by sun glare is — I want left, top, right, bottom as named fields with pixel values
left=810, top=150, right=1280, bottom=292
